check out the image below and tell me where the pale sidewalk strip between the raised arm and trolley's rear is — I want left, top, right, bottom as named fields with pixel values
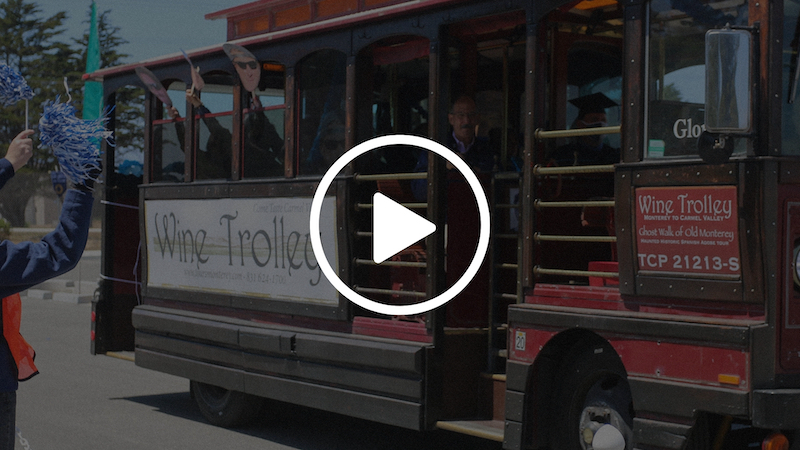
left=20, top=250, right=100, bottom=304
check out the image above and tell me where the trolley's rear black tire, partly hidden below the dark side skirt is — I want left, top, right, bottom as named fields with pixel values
left=189, top=381, right=264, bottom=428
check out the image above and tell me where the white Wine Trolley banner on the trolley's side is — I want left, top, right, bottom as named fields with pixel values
left=145, top=197, right=339, bottom=306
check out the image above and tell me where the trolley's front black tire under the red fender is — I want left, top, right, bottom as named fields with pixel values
left=550, top=342, right=633, bottom=450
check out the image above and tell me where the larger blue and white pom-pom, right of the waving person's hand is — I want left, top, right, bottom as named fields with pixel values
left=39, top=98, right=111, bottom=185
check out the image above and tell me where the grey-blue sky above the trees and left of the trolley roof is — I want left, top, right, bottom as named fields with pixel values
left=37, top=0, right=250, bottom=63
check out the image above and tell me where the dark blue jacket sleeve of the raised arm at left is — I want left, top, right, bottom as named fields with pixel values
left=0, top=189, right=93, bottom=298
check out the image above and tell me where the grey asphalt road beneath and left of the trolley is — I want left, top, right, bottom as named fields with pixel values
left=10, top=258, right=501, bottom=450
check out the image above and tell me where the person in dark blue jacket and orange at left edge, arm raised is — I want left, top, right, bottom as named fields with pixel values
left=0, top=130, right=94, bottom=450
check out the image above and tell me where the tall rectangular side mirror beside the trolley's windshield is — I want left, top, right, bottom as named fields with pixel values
left=705, top=29, right=753, bottom=134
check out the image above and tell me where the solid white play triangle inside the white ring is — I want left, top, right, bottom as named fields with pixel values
left=372, top=192, right=436, bottom=264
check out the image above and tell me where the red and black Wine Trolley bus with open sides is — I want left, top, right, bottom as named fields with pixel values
left=87, top=0, right=800, bottom=449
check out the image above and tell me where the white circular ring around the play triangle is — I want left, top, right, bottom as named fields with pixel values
left=309, top=134, right=490, bottom=316
